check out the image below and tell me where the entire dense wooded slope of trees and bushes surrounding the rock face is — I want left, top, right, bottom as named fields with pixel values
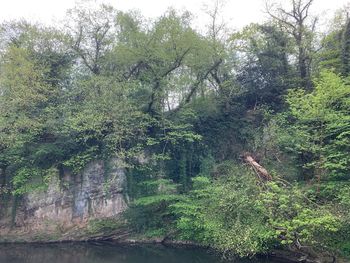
left=0, top=0, right=350, bottom=262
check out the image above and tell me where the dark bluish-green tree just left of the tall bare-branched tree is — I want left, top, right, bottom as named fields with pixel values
left=231, top=24, right=296, bottom=110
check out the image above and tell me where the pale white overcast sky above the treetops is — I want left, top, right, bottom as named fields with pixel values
left=0, top=0, right=350, bottom=29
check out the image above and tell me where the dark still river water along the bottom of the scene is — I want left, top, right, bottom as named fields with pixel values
left=0, top=243, right=284, bottom=263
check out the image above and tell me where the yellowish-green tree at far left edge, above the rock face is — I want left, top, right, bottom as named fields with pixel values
left=0, top=46, right=57, bottom=192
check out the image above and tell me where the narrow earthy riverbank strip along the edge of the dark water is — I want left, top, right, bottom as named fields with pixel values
left=0, top=228, right=342, bottom=263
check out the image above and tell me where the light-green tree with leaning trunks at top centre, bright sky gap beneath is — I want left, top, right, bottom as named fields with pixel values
left=110, top=10, right=221, bottom=116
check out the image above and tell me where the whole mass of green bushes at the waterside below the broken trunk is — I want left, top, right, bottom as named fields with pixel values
left=170, top=164, right=341, bottom=256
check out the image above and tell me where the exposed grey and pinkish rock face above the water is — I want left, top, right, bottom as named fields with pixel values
left=0, top=159, right=128, bottom=239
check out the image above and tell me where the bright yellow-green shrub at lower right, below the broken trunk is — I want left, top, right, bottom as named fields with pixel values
left=260, top=183, right=340, bottom=247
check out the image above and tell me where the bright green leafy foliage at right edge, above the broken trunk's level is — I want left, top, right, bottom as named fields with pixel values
left=287, top=72, right=350, bottom=177
